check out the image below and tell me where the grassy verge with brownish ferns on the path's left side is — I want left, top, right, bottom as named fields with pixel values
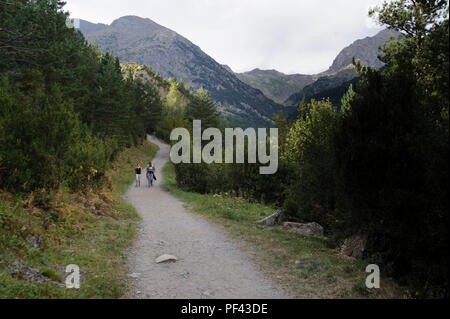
left=0, top=142, right=158, bottom=298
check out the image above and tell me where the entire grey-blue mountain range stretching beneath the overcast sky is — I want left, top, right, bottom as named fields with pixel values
left=80, top=16, right=399, bottom=127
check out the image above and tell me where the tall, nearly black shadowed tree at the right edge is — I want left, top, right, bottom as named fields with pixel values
left=336, top=1, right=449, bottom=296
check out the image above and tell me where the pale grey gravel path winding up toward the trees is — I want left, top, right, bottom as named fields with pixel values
left=125, top=137, right=286, bottom=299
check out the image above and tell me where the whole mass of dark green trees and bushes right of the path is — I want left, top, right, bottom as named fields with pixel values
left=171, top=0, right=449, bottom=297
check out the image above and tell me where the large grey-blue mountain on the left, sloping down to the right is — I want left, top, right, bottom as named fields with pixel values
left=80, top=16, right=282, bottom=126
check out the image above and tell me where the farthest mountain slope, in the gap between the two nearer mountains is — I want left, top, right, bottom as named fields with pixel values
left=236, top=69, right=317, bottom=104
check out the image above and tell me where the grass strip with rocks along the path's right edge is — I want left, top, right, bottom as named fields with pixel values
left=163, top=162, right=402, bottom=298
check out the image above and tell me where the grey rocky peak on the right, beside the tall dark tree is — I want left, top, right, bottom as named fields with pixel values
left=328, top=29, right=400, bottom=72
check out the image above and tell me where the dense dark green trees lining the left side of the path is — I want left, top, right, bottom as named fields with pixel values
left=0, top=0, right=162, bottom=192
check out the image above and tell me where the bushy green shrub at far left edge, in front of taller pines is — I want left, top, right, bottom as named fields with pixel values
left=0, top=74, right=80, bottom=191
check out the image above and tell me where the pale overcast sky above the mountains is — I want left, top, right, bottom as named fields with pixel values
left=65, top=0, right=383, bottom=74
